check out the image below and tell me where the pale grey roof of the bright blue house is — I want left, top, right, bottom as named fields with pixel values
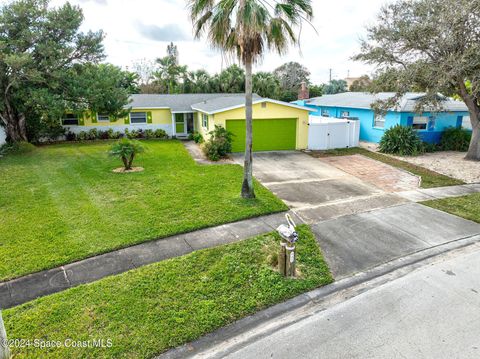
left=305, top=92, right=468, bottom=112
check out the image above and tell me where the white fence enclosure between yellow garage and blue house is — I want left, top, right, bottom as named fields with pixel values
left=308, top=116, right=360, bottom=150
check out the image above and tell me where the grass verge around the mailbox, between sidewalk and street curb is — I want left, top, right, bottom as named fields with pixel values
left=3, top=225, right=333, bottom=358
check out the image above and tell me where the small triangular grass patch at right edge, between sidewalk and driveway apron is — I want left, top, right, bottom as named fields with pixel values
left=422, top=193, right=480, bottom=223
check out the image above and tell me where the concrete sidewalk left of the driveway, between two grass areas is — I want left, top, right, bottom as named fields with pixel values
left=0, top=212, right=301, bottom=309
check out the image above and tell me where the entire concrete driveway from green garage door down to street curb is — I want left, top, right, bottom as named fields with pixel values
left=235, top=152, right=480, bottom=279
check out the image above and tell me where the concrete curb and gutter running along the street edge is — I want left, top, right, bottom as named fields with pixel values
left=156, top=235, right=480, bottom=359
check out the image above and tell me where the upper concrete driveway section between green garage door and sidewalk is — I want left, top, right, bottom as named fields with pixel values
left=234, top=152, right=406, bottom=224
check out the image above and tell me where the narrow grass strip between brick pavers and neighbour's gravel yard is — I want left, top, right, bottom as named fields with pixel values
left=310, top=147, right=465, bottom=188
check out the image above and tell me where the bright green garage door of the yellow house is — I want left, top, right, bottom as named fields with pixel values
left=226, top=118, right=297, bottom=152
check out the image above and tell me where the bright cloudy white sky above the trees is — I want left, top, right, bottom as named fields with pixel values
left=51, top=0, right=387, bottom=83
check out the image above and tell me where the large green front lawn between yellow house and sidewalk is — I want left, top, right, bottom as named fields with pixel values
left=0, top=141, right=287, bottom=280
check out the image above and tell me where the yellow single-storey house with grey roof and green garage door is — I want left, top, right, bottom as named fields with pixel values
left=63, top=94, right=311, bottom=152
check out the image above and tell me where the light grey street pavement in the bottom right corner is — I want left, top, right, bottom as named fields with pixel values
left=226, top=246, right=480, bottom=359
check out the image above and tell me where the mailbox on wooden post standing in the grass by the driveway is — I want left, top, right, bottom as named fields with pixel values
left=277, top=213, right=298, bottom=277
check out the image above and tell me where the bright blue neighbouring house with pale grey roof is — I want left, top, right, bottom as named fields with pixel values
left=294, top=92, right=471, bottom=143
